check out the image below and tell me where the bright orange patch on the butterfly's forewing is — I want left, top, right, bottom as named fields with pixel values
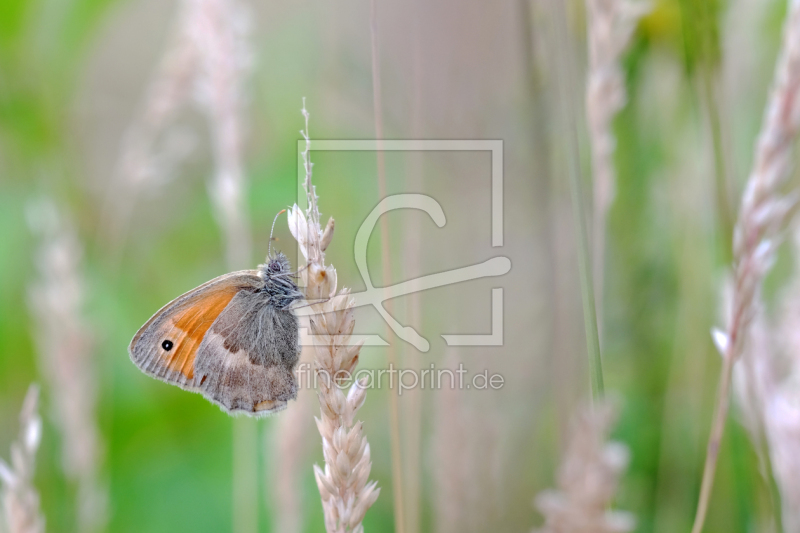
left=164, top=287, right=239, bottom=379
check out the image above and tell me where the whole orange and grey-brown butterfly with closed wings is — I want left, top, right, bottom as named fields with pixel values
left=128, top=247, right=303, bottom=416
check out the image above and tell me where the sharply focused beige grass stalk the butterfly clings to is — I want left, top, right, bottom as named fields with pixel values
left=289, top=102, right=380, bottom=533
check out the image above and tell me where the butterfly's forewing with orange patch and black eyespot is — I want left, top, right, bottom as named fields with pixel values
left=128, top=270, right=263, bottom=392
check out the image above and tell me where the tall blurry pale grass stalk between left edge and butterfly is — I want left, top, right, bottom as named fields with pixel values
left=28, top=199, right=108, bottom=533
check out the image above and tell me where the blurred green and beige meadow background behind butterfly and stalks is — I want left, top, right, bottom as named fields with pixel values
left=0, top=0, right=785, bottom=532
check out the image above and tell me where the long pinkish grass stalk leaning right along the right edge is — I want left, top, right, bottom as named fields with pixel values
left=692, top=0, right=800, bottom=533
